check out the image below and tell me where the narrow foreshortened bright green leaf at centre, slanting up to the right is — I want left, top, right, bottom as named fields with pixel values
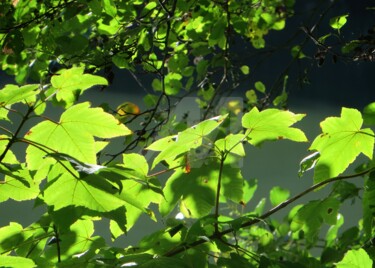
left=146, top=115, right=227, bottom=168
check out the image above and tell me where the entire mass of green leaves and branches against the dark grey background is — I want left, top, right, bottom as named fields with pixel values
left=0, top=0, right=375, bottom=267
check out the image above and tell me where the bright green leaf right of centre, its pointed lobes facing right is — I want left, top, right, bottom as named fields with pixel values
left=242, top=107, right=307, bottom=146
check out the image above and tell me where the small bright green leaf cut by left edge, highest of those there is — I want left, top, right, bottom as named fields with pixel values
left=0, top=84, right=39, bottom=105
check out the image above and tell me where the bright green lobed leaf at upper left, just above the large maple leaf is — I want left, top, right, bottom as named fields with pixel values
left=51, top=67, right=108, bottom=107
